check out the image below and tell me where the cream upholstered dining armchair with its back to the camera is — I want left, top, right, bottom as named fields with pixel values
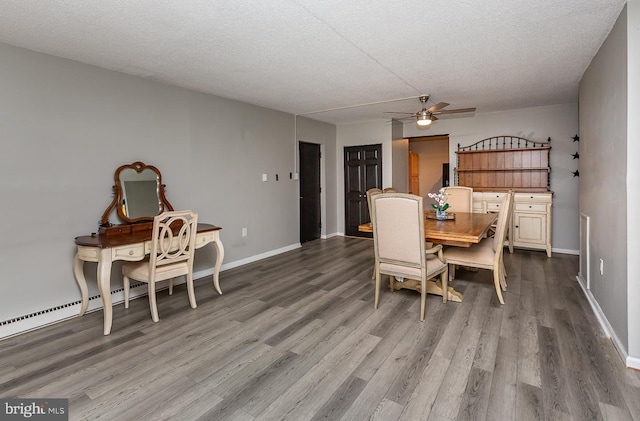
left=372, top=193, right=448, bottom=321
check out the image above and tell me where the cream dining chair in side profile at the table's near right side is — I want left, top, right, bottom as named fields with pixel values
left=444, top=192, right=513, bottom=304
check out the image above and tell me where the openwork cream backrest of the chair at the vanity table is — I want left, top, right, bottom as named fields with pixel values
left=149, top=210, right=198, bottom=277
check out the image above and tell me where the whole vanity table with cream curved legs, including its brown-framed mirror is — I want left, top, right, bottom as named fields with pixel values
left=73, top=162, right=224, bottom=335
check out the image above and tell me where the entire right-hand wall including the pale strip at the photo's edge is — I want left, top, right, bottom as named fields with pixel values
left=580, top=2, right=640, bottom=368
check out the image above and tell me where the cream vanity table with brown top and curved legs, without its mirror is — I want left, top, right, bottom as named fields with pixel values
left=73, top=224, right=224, bottom=335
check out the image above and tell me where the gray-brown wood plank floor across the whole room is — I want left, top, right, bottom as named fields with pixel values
left=0, top=237, right=640, bottom=421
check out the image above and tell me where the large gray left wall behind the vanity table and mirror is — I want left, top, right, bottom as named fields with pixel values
left=0, top=44, right=302, bottom=321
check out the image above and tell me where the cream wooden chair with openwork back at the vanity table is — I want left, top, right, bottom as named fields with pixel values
left=122, top=210, right=198, bottom=322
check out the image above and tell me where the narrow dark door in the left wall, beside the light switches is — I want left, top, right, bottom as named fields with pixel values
left=298, top=142, right=322, bottom=243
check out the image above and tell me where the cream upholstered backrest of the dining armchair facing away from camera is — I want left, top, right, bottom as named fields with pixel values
left=372, top=193, right=426, bottom=269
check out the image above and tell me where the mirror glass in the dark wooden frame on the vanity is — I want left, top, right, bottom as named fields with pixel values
left=118, top=168, right=162, bottom=219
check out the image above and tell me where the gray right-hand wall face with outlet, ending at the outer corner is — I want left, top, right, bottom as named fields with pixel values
left=580, top=4, right=628, bottom=348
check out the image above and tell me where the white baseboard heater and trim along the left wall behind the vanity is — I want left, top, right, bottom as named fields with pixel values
left=0, top=243, right=300, bottom=340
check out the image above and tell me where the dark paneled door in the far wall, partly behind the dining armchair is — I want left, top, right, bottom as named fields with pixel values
left=344, top=144, right=382, bottom=237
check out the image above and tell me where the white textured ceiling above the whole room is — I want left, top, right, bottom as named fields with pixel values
left=0, top=0, right=625, bottom=124
